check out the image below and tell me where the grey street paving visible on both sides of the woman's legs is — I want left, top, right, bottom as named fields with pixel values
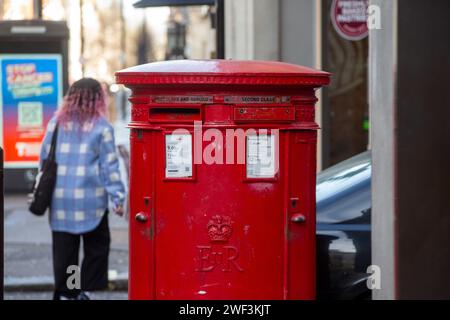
left=4, top=195, right=128, bottom=299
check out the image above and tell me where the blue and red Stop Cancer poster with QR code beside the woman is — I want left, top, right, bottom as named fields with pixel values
left=0, top=54, right=62, bottom=168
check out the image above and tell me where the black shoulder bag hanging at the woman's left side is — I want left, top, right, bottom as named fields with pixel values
left=28, top=124, right=58, bottom=216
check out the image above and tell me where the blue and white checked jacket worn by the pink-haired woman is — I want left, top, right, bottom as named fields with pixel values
left=40, top=117, right=125, bottom=234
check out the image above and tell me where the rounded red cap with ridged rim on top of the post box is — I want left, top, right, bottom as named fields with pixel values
left=116, top=59, right=330, bottom=87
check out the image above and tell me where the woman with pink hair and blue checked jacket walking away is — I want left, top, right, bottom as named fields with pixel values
left=40, top=78, right=125, bottom=300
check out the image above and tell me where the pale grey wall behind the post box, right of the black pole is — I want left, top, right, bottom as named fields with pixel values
left=225, top=0, right=322, bottom=171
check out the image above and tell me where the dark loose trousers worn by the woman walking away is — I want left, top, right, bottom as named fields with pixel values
left=52, top=210, right=110, bottom=300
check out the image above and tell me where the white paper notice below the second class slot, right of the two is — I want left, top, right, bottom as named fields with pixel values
left=246, top=134, right=275, bottom=178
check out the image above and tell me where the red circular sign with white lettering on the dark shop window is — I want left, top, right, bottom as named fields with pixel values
left=331, top=0, right=369, bottom=41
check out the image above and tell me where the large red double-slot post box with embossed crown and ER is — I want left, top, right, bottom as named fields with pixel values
left=116, top=60, right=330, bottom=299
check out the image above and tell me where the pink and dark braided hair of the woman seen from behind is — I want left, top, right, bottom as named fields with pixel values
left=57, top=78, right=106, bottom=128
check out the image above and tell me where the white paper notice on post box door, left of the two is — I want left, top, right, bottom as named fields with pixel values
left=166, top=134, right=192, bottom=178
